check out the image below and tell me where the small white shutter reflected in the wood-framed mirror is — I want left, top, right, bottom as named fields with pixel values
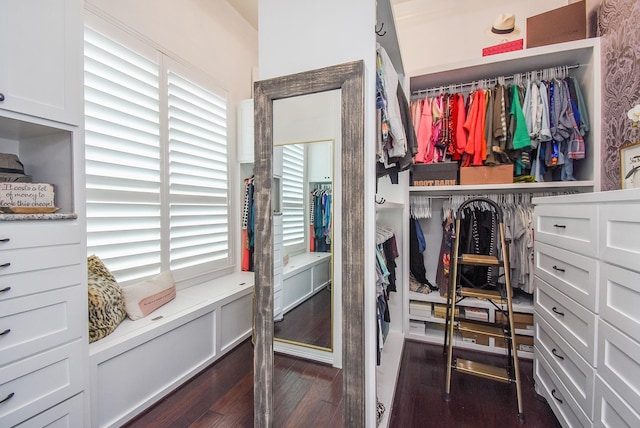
left=282, top=144, right=305, bottom=253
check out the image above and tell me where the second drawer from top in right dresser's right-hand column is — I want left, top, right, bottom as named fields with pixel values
left=598, top=259, right=640, bottom=342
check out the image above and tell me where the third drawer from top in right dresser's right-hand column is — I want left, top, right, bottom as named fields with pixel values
left=598, top=320, right=640, bottom=413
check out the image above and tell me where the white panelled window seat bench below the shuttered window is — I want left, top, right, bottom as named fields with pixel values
left=89, top=272, right=254, bottom=427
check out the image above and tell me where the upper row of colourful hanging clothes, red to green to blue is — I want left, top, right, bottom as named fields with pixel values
left=410, top=69, right=589, bottom=182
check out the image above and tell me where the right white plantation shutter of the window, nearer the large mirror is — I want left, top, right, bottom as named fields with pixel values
left=167, top=71, right=229, bottom=270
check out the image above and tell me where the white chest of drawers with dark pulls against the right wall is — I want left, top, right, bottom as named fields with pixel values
left=534, top=189, right=640, bottom=427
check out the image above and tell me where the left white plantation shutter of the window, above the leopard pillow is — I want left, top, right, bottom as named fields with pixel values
left=84, top=28, right=161, bottom=281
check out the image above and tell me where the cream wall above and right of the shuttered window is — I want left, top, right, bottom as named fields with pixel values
left=85, top=0, right=258, bottom=270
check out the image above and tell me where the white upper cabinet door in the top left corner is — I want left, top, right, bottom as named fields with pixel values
left=0, top=0, right=83, bottom=125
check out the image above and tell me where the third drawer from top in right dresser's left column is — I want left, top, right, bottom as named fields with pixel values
left=534, top=277, right=597, bottom=366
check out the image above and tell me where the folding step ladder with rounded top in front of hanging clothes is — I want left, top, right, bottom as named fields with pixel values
left=443, top=198, right=524, bottom=422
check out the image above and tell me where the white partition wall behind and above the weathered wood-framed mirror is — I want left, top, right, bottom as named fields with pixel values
left=258, top=0, right=376, bottom=426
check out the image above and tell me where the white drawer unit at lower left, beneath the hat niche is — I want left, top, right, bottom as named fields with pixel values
left=0, top=220, right=88, bottom=426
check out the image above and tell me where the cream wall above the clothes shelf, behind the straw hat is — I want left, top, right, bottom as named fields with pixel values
left=393, top=0, right=568, bottom=76
